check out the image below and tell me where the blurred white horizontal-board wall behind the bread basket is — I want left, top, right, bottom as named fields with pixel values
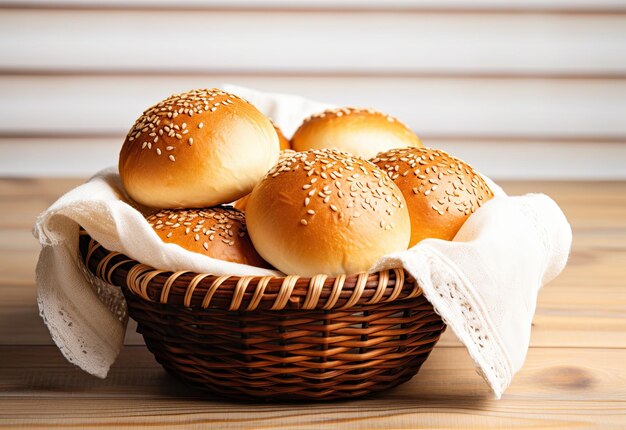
left=0, top=0, right=626, bottom=179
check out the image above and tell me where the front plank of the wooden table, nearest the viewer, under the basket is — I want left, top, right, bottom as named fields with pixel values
left=0, top=347, right=626, bottom=428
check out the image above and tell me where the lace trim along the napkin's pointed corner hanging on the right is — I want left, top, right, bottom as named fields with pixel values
left=420, top=248, right=513, bottom=399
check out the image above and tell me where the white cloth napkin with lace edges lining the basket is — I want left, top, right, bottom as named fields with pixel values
left=34, top=86, right=572, bottom=398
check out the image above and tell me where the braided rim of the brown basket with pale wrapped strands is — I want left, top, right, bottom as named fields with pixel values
left=79, top=229, right=422, bottom=311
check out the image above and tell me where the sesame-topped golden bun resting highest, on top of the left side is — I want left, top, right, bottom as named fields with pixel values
left=119, top=89, right=279, bottom=208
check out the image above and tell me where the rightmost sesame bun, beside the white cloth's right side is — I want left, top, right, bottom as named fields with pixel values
left=371, top=148, right=493, bottom=246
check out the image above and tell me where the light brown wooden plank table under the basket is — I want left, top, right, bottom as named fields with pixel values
left=0, top=179, right=626, bottom=429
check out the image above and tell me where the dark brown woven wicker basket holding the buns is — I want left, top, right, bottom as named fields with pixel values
left=80, top=231, right=445, bottom=400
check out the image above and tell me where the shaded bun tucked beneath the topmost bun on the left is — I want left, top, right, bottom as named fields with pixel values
left=147, top=206, right=271, bottom=268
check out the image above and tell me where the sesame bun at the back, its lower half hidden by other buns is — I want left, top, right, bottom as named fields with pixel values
left=291, top=108, right=422, bottom=159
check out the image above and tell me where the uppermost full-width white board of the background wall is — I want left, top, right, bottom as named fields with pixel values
left=0, top=9, right=626, bottom=75
